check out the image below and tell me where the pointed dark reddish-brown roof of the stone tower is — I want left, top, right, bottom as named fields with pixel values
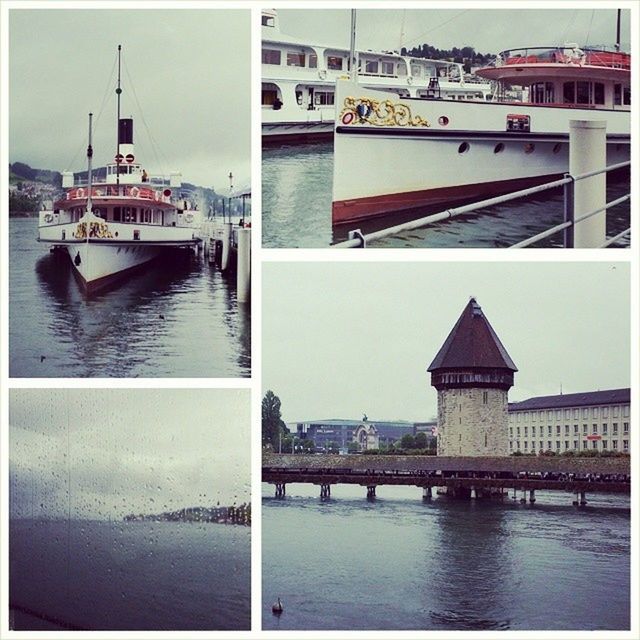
left=427, top=298, right=518, bottom=371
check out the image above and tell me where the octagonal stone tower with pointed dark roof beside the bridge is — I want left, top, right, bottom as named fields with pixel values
left=427, top=298, right=518, bottom=456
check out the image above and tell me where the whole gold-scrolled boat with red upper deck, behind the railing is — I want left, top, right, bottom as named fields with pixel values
left=333, top=44, right=631, bottom=224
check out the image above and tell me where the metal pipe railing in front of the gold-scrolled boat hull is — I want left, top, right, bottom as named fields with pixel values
left=333, top=160, right=631, bottom=249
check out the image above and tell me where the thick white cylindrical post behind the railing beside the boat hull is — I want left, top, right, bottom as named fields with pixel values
left=569, top=120, right=607, bottom=249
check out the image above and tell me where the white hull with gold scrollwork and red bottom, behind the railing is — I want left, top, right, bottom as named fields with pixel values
left=332, top=82, right=630, bottom=224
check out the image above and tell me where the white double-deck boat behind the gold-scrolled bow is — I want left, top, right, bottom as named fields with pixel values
left=262, top=10, right=492, bottom=143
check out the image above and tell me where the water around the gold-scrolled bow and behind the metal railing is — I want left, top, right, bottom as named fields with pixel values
left=262, top=142, right=630, bottom=248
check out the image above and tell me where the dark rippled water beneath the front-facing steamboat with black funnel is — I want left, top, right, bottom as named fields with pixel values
left=9, top=218, right=251, bottom=378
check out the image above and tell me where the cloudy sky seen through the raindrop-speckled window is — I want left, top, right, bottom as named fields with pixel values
left=9, top=389, right=251, bottom=519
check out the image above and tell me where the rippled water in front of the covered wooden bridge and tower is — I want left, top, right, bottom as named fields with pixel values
left=262, top=484, right=630, bottom=631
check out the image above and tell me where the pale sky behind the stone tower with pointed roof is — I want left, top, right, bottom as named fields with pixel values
left=262, top=262, right=630, bottom=422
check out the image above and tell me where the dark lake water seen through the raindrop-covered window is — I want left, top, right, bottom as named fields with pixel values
left=9, top=520, right=251, bottom=630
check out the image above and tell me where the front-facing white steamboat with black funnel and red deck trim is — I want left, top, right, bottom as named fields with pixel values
left=38, top=46, right=202, bottom=292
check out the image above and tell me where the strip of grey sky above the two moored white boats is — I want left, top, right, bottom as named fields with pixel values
left=278, top=3, right=629, bottom=53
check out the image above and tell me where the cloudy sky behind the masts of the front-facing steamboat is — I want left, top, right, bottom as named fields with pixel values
left=9, top=8, right=251, bottom=190
